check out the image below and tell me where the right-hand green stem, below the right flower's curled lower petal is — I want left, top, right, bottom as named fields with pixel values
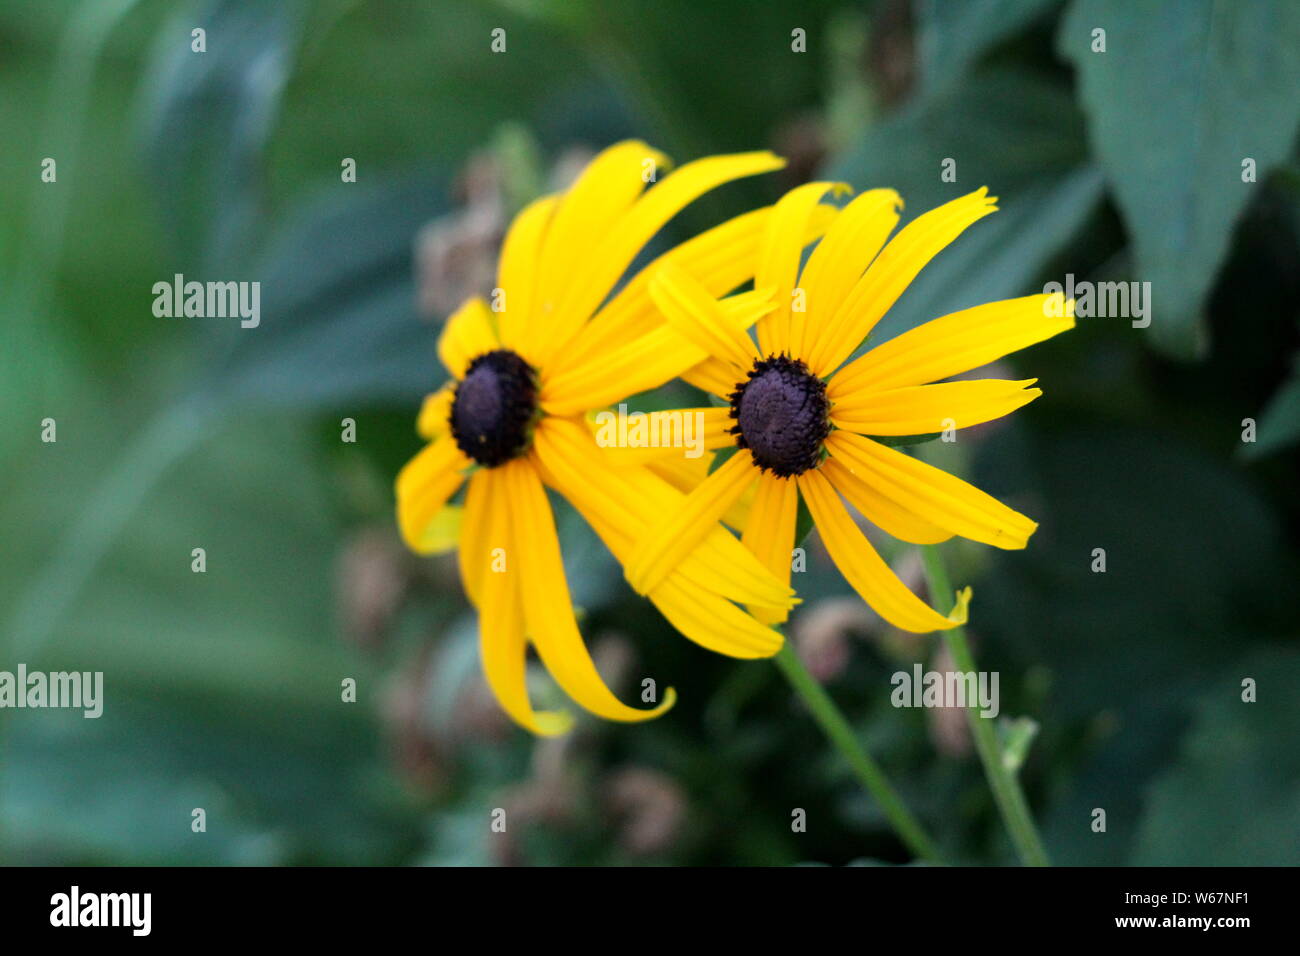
left=920, top=545, right=1050, bottom=866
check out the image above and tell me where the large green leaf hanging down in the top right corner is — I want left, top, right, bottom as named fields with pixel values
left=1057, top=0, right=1300, bottom=358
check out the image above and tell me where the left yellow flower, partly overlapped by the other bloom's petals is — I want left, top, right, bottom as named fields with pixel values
left=397, top=142, right=794, bottom=734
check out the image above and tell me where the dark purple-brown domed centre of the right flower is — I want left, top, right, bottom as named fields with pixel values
left=731, top=355, right=831, bottom=477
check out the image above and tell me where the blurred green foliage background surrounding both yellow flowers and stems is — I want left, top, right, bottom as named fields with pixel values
left=0, top=0, right=1300, bottom=865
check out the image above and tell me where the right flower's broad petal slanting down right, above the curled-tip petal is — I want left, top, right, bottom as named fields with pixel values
left=826, top=431, right=1039, bottom=549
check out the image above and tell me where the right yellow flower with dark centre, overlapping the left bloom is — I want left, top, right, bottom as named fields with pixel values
left=627, top=182, right=1074, bottom=633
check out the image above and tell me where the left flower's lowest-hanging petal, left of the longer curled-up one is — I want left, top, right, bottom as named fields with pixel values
left=471, top=471, right=573, bottom=736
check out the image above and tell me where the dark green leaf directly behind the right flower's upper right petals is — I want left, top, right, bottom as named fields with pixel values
left=827, top=70, right=1102, bottom=342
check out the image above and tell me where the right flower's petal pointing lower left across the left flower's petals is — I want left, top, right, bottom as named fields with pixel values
left=624, top=449, right=758, bottom=594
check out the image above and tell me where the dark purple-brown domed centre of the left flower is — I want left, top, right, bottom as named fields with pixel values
left=451, top=349, right=537, bottom=468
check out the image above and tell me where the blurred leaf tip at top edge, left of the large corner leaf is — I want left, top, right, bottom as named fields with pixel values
left=917, top=0, right=1058, bottom=94
